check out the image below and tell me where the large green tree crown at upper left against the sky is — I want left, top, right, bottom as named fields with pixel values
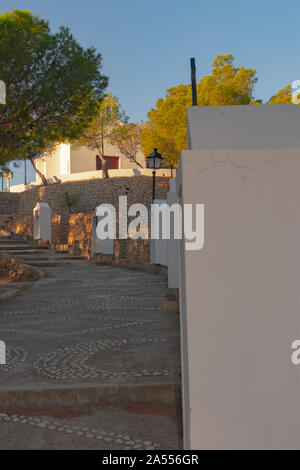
left=0, top=10, right=108, bottom=178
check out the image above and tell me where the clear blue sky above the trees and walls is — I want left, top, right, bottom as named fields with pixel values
left=0, top=0, right=300, bottom=184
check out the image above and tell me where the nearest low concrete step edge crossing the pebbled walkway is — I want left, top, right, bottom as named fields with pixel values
left=0, top=384, right=181, bottom=409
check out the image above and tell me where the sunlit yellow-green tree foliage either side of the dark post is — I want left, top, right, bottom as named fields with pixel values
left=141, top=54, right=257, bottom=166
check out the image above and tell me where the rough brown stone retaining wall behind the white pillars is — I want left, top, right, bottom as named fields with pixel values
left=0, top=176, right=169, bottom=261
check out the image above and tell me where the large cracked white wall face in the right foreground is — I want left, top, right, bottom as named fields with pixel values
left=177, top=143, right=300, bottom=449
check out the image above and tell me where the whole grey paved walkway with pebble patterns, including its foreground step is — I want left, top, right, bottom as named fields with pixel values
left=0, top=241, right=181, bottom=449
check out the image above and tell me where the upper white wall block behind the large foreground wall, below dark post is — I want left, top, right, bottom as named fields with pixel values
left=188, top=104, right=300, bottom=150
